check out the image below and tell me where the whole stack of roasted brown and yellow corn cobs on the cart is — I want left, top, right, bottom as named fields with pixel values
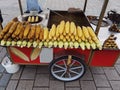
left=0, top=20, right=102, bottom=50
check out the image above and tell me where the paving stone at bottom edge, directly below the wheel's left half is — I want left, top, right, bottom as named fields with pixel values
left=49, top=80, right=64, bottom=90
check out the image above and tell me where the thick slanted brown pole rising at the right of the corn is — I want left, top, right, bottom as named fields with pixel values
left=95, top=0, right=109, bottom=35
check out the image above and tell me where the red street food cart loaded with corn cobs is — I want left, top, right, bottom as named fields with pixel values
left=0, top=0, right=120, bottom=81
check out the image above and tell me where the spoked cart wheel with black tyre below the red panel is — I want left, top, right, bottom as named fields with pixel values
left=49, top=56, right=86, bottom=81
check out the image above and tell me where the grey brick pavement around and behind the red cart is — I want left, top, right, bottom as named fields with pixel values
left=0, top=0, right=120, bottom=90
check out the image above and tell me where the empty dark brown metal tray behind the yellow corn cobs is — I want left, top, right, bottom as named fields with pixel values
left=48, top=10, right=91, bottom=28
